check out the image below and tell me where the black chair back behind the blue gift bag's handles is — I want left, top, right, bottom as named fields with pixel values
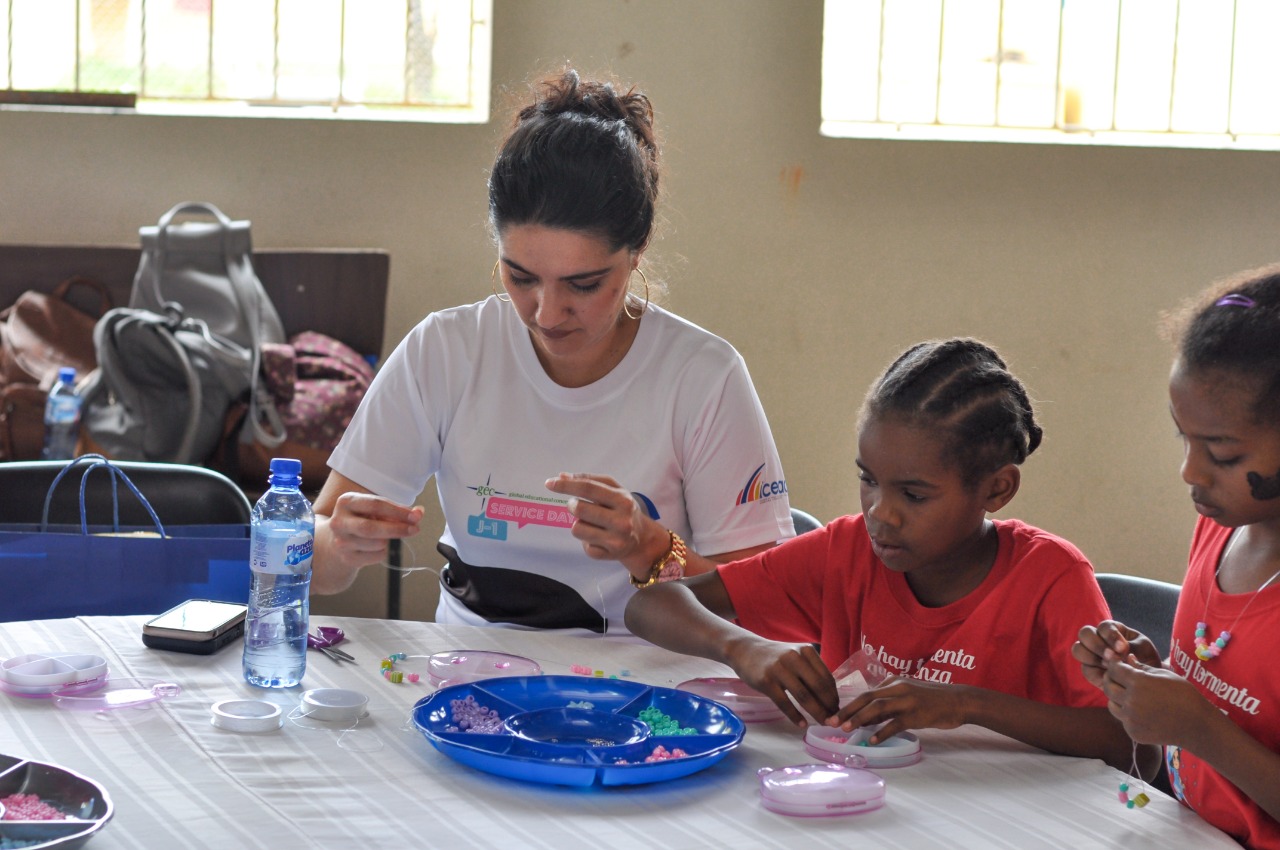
left=0, top=461, right=252, bottom=526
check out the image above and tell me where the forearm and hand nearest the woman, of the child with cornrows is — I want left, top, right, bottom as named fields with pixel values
left=626, top=570, right=838, bottom=727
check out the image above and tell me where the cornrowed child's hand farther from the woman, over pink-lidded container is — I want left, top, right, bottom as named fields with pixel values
left=828, top=676, right=969, bottom=744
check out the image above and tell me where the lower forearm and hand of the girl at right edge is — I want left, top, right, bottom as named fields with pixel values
left=1102, top=652, right=1280, bottom=821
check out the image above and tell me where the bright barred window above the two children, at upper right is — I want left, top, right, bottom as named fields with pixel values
left=822, top=0, right=1280, bottom=150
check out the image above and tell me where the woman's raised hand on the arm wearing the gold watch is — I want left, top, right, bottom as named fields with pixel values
left=547, top=472, right=671, bottom=581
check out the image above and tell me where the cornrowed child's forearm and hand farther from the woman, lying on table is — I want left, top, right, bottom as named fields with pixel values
left=836, top=677, right=1160, bottom=778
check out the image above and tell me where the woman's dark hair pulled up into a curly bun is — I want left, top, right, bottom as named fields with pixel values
left=489, top=68, right=658, bottom=251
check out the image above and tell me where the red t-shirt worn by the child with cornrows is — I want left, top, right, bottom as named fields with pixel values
left=719, top=515, right=1110, bottom=707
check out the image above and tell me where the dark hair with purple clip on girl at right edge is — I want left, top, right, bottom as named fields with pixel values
left=1162, top=264, right=1280, bottom=428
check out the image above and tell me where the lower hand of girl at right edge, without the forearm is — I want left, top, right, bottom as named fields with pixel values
left=1101, top=659, right=1219, bottom=746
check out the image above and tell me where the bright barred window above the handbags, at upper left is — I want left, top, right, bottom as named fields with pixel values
left=0, top=0, right=492, bottom=123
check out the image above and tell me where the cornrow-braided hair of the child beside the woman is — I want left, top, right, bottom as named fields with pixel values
left=861, top=339, right=1043, bottom=486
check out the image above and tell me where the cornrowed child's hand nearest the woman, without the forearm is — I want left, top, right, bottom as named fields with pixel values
left=726, top=635, right=840, bottom=728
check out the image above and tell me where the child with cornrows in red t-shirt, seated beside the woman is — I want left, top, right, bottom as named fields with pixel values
left=626, top=339, right=1158, bottom=772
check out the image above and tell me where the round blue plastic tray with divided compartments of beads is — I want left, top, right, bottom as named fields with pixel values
left=413, top=676, right=746, bottom=786
